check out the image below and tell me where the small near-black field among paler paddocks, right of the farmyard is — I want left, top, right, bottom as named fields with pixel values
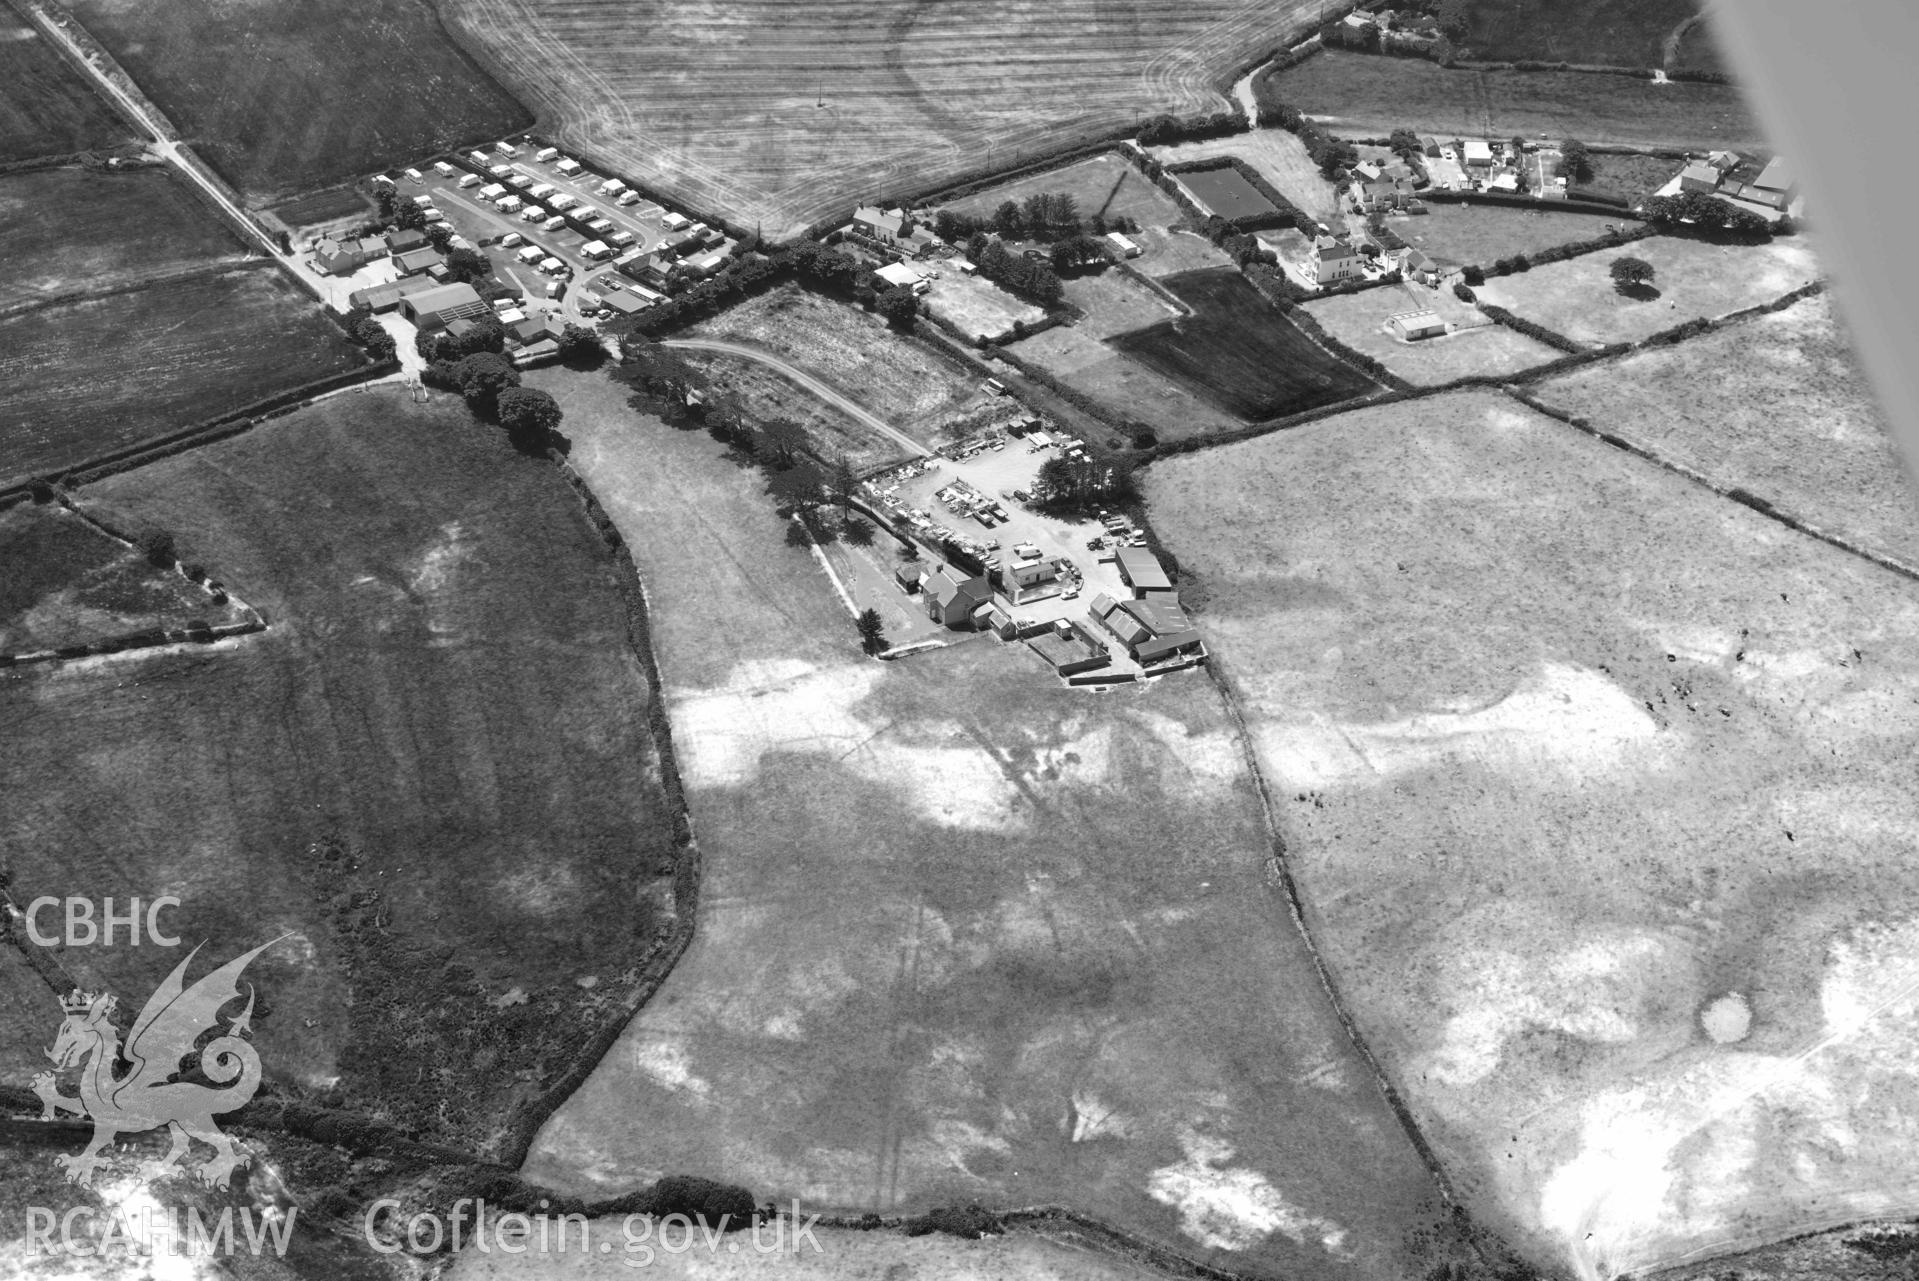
left=1113, top=270, right=1372, bottom=422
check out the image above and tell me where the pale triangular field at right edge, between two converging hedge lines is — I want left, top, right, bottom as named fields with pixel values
left=1535, top=293, right=1919, bottom=566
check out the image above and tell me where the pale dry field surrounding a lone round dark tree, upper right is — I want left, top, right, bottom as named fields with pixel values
left=1476, top=236, right=1819, bottom=347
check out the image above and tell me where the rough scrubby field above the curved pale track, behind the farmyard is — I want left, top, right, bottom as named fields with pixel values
left=685, top=284, right=979, bottom=456
